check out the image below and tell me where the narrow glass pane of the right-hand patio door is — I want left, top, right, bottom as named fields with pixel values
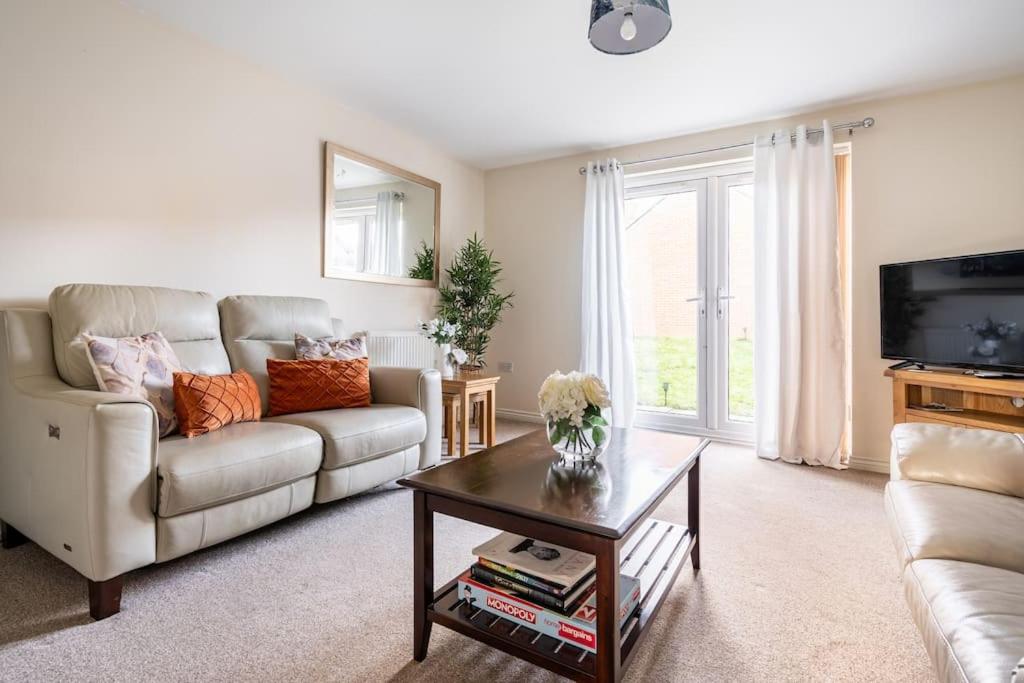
left=727, top=184, right=754, bottom=422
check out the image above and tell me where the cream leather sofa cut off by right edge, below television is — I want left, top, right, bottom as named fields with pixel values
left=885, top=424, right=1024, bottom=683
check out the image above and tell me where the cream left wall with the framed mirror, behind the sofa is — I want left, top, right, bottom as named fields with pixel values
left=0, top=0, right=483, bottom=329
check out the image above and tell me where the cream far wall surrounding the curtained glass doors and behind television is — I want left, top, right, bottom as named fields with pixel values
left=486, top=77, right=1024, bottom=470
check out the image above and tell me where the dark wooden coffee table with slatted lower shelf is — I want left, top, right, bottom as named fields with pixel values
left=398, top=429, right=708, bottom=681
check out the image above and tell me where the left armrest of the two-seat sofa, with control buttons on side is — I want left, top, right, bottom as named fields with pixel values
left=0, top=311, right=158, bottom=581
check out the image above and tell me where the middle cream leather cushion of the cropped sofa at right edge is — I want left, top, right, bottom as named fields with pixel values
left=885, top=480, right=1024, bottom=572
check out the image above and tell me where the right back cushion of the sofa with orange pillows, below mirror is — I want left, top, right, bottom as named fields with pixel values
left=219, top=296, right=335, bottom=412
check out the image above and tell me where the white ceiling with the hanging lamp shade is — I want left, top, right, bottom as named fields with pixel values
left=126, top=0, right=1024, bottom=168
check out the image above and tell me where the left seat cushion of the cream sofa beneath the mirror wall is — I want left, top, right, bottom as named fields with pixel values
left=157, top=422, right=324, bottom=517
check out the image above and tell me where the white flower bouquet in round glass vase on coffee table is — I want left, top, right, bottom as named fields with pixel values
left=537, top=372, right=611, bottom=456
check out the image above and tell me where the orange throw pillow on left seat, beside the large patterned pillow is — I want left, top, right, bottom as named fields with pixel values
left=174, top=370, right=263, bottom=438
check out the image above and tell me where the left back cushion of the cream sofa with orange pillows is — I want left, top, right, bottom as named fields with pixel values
left=49, top=285, right=231, bottom=389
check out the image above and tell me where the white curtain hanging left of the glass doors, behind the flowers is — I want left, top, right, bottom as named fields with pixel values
left=581, top=159, right=636, bottom=427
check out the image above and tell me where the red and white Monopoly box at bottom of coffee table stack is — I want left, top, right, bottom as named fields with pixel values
left=459, top=571, right=640, bottom=652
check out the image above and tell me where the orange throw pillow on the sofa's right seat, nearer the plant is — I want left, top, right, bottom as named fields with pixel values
left=266, top=358, right=370, bottom=415
